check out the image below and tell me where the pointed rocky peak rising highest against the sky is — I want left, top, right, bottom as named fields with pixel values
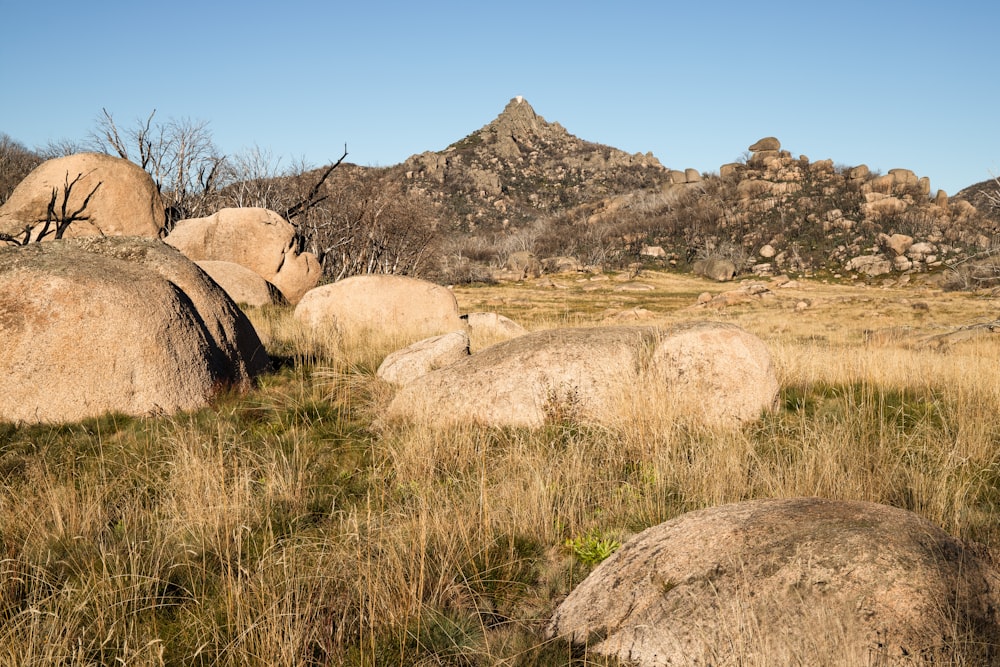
left=401, top=96, right=669, bottom=228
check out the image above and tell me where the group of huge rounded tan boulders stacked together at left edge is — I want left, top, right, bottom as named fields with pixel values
left=0, top=153, right=319, bottom=422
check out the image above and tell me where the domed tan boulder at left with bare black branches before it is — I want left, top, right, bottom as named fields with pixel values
left=0, top=153, right=165, bottom=240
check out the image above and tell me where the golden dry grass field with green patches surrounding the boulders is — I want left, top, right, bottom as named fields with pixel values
left=0, top=273, right=1000, bottom=666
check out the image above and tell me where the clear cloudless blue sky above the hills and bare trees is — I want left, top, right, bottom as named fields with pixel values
left=0, top=0, right=1000, bottom=194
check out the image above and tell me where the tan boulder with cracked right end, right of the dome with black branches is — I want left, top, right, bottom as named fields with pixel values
left=164, top=208, right=322, bottom=303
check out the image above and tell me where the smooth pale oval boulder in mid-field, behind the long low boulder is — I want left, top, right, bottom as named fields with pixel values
left=295, top=275, right=465, bottom=345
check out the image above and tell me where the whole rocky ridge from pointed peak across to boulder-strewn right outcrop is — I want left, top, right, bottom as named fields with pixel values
left=370, top=97, right=1000, bottom=286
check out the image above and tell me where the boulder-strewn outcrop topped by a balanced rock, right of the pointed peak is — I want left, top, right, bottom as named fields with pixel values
left=719, top=137, right=992, bottom=277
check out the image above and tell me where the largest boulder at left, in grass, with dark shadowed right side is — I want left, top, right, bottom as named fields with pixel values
left=0, top=237, right=268, bottom=422
